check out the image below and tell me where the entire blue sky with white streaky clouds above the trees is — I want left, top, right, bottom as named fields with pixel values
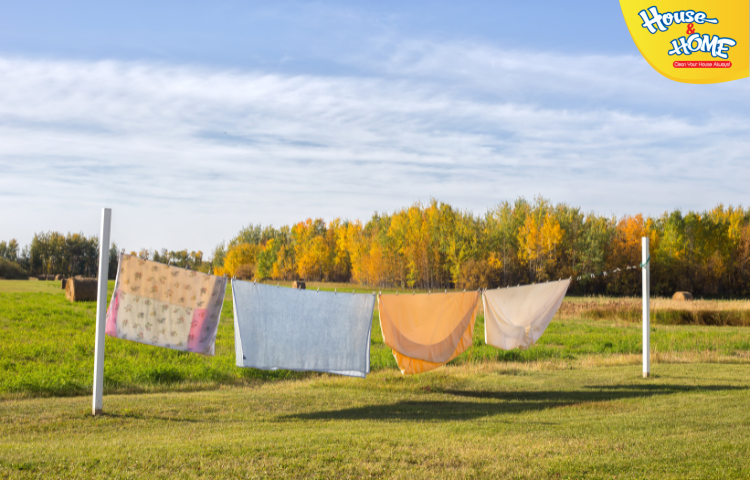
left=0, top=0, right=750, bottom=253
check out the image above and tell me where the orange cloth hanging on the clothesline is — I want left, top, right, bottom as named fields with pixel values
left=378, top=292, right=479, bottom=375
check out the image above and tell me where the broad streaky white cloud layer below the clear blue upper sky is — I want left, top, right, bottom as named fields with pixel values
left=0, top=42, right=750, bottom=255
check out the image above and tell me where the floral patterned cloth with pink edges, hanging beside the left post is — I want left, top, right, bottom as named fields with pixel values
left=105, top=254, right=227, bottom=355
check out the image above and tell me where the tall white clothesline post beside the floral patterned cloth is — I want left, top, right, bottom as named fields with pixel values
left=91, top=208, right=112, bottom=415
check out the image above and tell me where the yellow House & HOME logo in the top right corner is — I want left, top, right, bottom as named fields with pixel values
left=620, top=0, right=750, bottom=83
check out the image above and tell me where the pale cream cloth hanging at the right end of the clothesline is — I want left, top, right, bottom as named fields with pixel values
left=482, top=279, right=570, bottom=350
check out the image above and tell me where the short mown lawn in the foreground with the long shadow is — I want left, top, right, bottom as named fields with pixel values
left=0, top=362, right=750, bottom=479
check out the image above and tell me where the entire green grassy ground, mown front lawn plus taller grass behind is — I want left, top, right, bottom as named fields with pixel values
left=0, top=281, right=750, bottom=479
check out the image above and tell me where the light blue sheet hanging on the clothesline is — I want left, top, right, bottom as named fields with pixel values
left=232, top=280, right=375, bottom=378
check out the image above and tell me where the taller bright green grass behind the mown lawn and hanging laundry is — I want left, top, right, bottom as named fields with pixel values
left=0, top=282, right=750, bottom=398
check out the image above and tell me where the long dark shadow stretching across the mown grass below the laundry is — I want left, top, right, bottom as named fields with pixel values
left=281, top=384, right=748, bottom=421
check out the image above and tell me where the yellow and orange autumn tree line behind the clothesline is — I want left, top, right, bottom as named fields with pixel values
left=212, top=197, right=750, bottom=297
